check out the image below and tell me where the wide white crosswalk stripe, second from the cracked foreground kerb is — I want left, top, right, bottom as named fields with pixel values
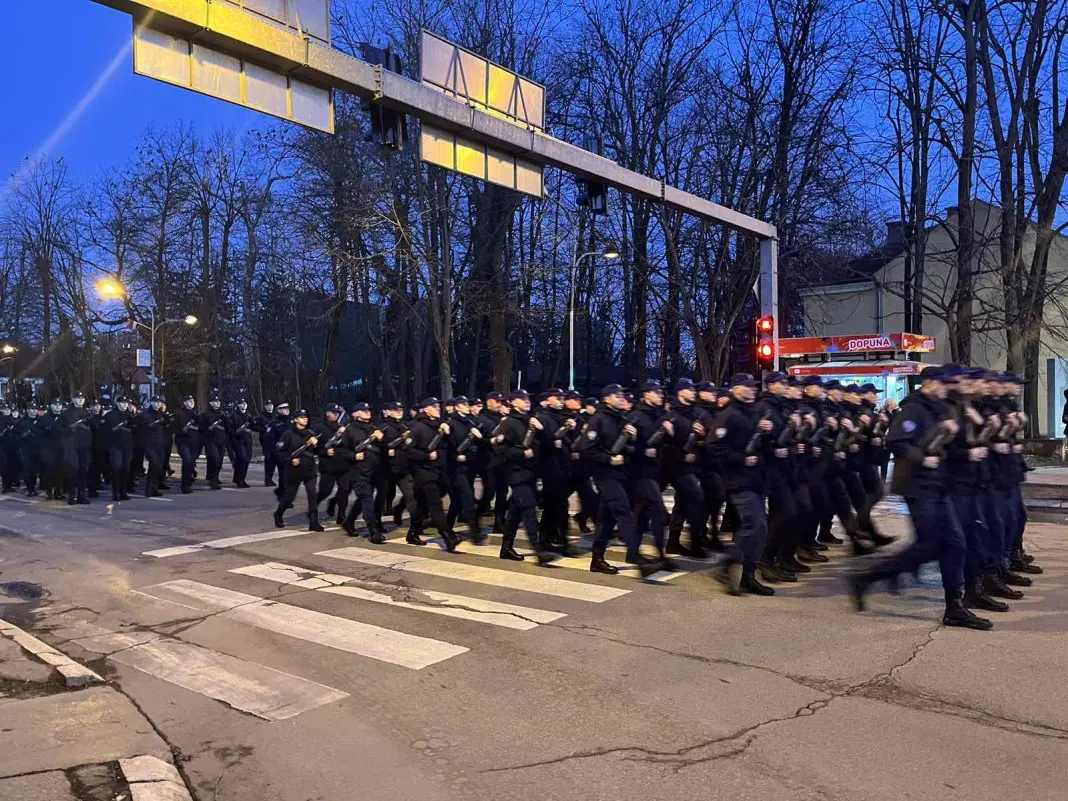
left=135, top=579, right=468, bottom=671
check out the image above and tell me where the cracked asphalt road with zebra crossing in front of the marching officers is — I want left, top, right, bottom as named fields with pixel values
left=0, top=463, right=1068, bottom=801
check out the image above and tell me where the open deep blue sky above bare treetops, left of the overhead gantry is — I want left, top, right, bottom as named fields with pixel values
left=0, top=0, right=262, bottom=186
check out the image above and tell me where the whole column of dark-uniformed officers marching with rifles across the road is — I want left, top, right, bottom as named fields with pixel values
left=0, top=365, right=1041, bottom=629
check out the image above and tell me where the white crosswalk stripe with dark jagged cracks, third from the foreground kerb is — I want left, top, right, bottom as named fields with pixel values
left=230, top=562, right=566, bottom=631
